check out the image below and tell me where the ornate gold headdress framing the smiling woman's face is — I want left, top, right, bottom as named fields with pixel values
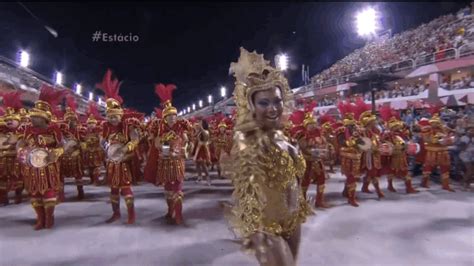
left=229, top=47, right=291, bottom=132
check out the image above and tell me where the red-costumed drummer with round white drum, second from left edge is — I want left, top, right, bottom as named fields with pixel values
left=17, top=85, right=64, bottom=230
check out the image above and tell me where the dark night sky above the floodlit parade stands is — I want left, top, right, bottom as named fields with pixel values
left=0, top=1, right=470, bottom=113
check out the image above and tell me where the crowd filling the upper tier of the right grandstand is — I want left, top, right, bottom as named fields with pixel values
left=313, top=5, right=474, bottom=83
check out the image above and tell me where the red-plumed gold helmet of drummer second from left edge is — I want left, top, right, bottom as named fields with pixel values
left=29, top=84, right=65, bottom=121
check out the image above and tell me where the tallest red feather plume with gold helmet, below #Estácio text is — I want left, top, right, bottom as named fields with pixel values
left=95, top=69, right=123, bottom=115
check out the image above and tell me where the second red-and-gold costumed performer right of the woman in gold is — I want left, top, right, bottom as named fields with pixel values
left=336, top=102, right=367, bottom=207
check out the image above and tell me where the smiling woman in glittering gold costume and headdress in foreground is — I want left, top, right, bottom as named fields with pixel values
left=227, top=48, right=311, bottom=265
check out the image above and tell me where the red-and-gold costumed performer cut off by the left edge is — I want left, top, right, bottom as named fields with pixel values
left=0, top=92, right=23, bottom=205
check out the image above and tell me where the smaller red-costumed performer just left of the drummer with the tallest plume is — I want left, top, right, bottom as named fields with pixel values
left=82, top=102, right=105, bottom=186
